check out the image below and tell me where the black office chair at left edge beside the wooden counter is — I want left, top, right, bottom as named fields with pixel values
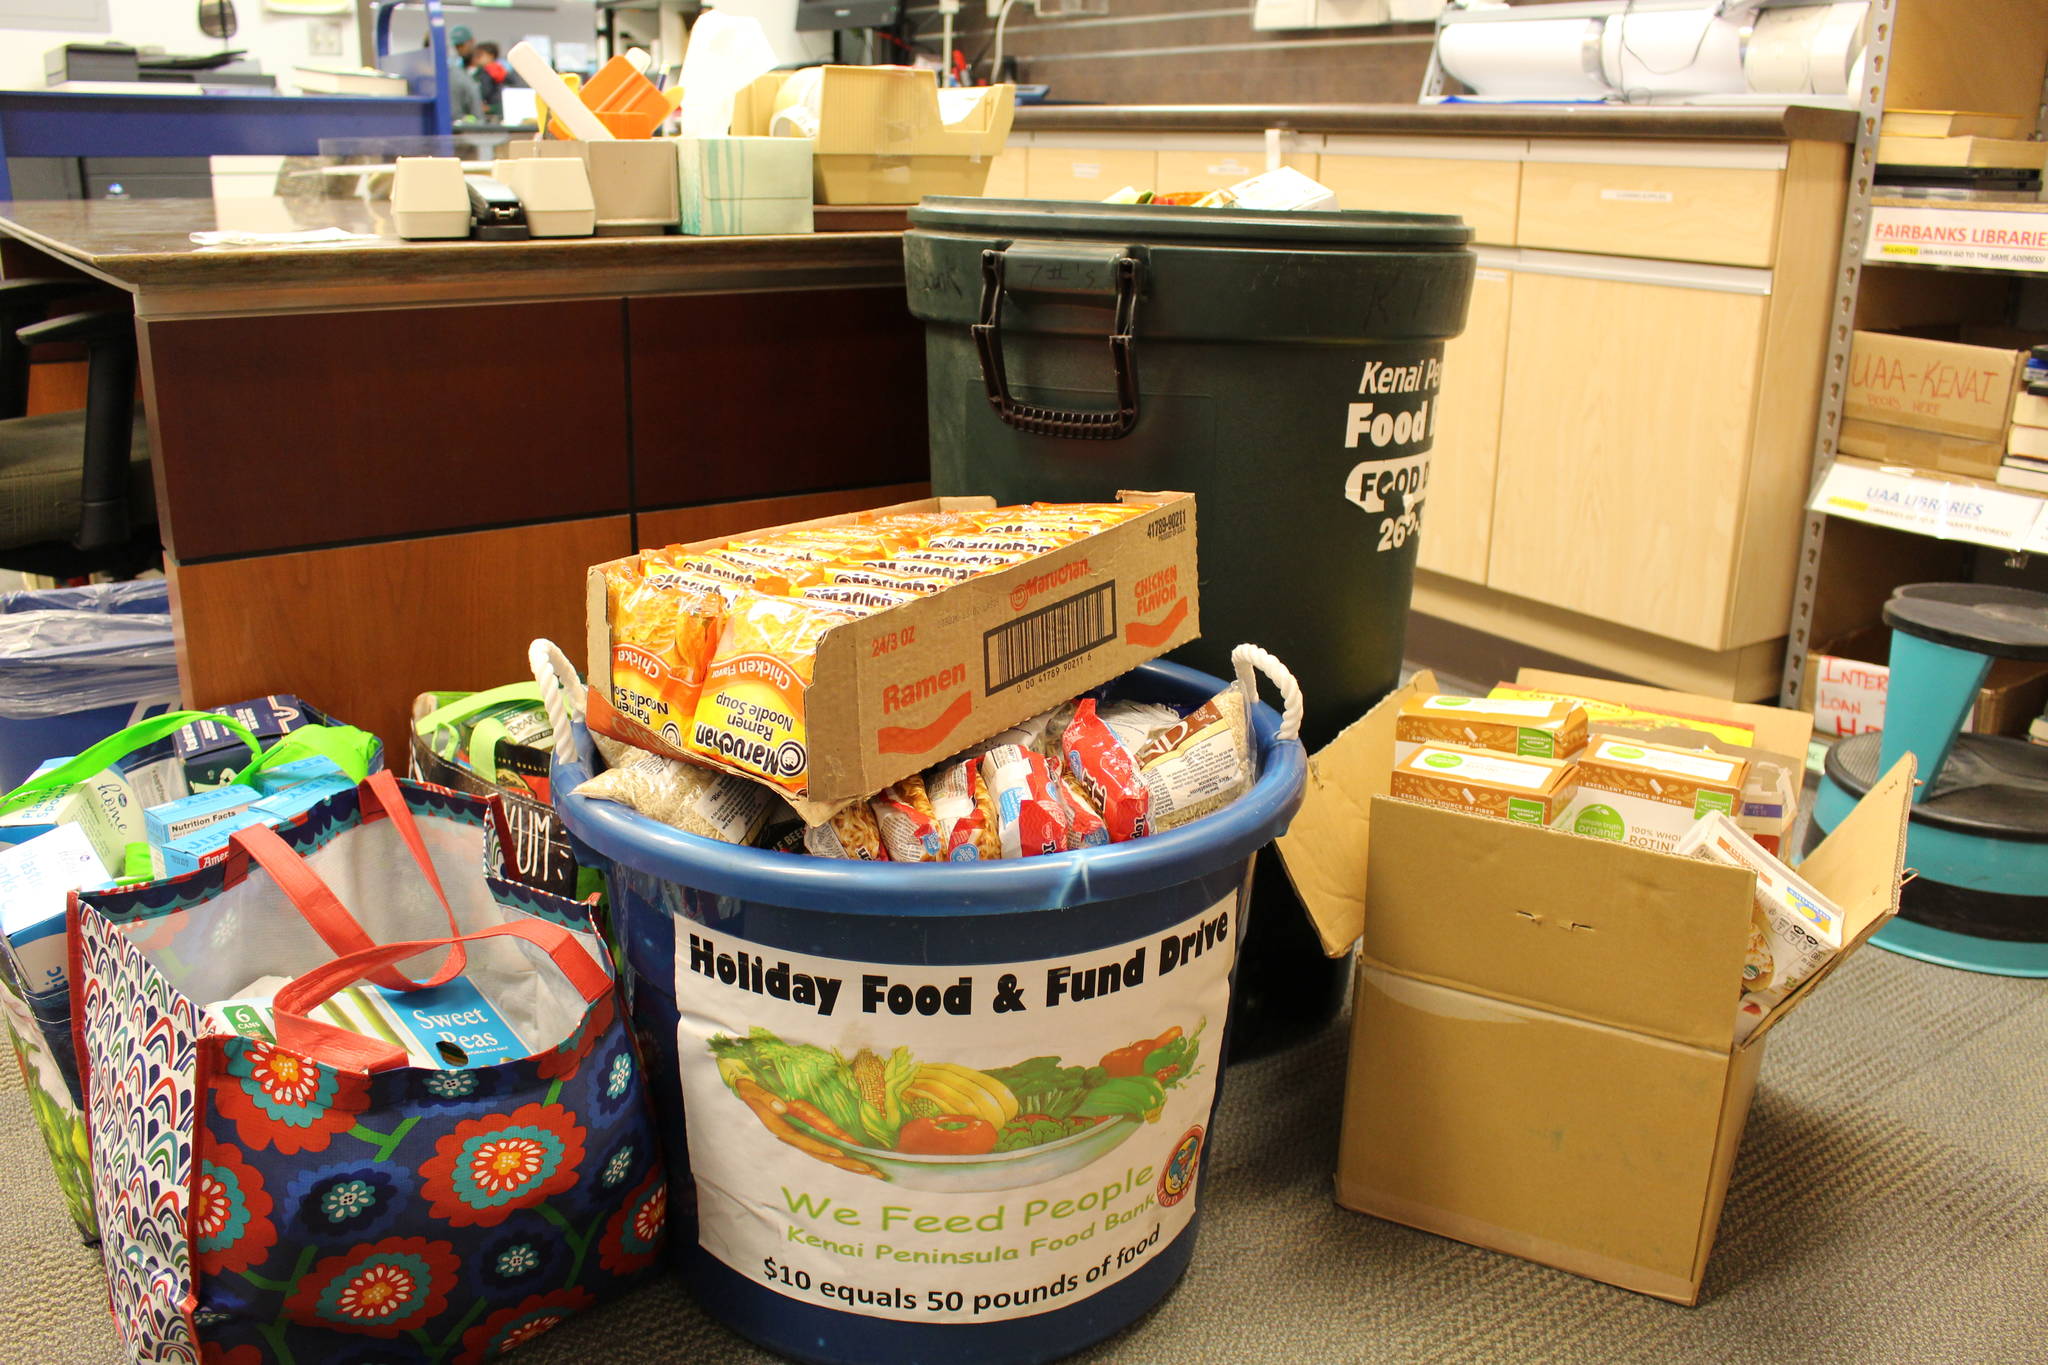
left=0, top=280, right=162, bottom=579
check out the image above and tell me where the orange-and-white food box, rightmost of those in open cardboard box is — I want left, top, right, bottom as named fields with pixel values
left=1559, top=739, right=1749, bottom=853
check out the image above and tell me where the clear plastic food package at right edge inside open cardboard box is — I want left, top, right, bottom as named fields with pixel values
left=1671, top=814, right=1843, bottom=1042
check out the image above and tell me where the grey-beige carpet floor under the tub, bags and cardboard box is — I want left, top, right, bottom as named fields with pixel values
left=0, top=950, right=2048, bottom=1365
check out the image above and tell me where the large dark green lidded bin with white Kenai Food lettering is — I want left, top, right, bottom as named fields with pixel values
left=903, top=199, right=1475, bottom=1058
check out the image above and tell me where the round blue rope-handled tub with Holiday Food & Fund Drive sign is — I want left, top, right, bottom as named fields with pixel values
left=553, top=663, right=1307, bottom=1365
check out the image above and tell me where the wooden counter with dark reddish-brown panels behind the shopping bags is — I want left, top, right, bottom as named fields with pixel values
left=0, top=201, right=928, bottom=753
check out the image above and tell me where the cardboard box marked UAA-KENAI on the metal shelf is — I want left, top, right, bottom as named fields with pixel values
left=1839, top=332, right=2021, bottom=479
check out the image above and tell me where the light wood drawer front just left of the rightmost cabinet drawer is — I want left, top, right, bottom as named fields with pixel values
left=1317, top=135, right=1528, bottom=246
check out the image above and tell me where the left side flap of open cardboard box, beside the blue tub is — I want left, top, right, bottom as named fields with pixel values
left=1278, top=669, right=1438, bottom=958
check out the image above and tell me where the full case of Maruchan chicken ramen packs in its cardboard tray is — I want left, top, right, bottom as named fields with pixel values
left=588, top=491, right=1200, bottom=825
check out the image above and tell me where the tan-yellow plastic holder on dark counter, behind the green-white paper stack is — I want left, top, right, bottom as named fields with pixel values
left=733, top=65, right=1016, bottom=205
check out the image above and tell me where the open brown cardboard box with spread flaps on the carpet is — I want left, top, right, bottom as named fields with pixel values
left=1280, top=671, right=1913, bottom=1304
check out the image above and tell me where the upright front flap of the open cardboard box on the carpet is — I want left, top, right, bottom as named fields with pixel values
left=1360, top=796, right=1755, bottom=1052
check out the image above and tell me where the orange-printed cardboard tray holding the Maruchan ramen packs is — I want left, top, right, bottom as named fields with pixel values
left=588, top=491, right=1202, bottom=825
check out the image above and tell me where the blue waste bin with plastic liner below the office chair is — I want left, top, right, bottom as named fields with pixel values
left=0, top=579, right=178, bottom=792
